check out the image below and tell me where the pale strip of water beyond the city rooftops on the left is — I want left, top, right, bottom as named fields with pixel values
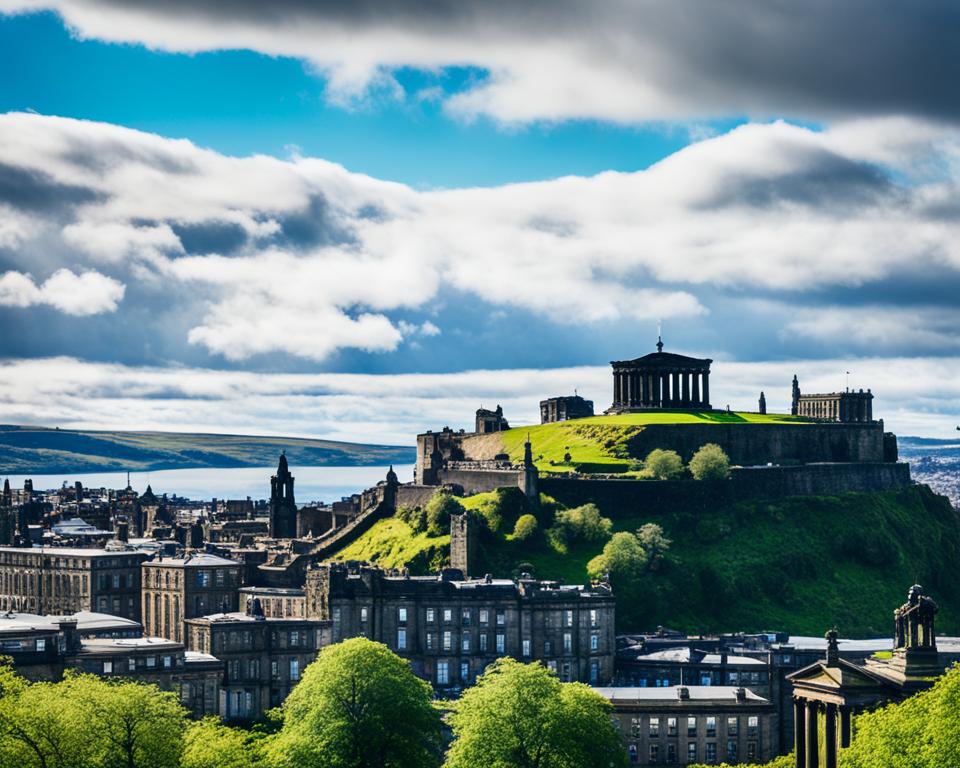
left=0, top=464, right=413, bottom=504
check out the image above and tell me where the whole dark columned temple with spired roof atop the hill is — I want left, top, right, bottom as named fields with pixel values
left=606, top=337, right=713, bottom=414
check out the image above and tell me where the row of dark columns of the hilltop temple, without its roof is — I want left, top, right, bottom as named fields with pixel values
left=613, top=366, right=710, bottom=408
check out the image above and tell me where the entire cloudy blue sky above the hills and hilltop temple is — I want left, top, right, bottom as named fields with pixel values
left=0, top=0, right=960, bottom=442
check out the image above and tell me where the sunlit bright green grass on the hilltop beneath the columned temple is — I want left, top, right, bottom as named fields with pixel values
left=474, top=411, right=810, bottom=472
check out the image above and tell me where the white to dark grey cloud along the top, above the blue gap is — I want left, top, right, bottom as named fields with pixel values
left=0, top=0, right=960, bottom=122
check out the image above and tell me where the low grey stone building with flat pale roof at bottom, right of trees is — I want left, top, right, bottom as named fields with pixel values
left=595, top=685, right=777, bottom=766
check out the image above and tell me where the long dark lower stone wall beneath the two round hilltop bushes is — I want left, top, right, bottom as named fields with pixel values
left=540, top=464, right=911, bottom=512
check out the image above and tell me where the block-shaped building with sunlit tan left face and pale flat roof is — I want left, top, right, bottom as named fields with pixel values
left=143, top=553, right=241, bottom=643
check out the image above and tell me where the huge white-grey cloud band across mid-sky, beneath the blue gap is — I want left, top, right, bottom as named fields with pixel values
left=0, top=114, right=960, bottom=360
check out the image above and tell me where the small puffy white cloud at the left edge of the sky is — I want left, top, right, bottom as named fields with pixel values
left=0, top=269, right=126, bottom=317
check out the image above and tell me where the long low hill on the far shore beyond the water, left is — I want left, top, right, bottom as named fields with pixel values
left=0, top=425, right=416, bottom=474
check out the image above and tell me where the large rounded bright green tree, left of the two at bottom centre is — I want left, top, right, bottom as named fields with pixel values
left=269, top=637, right=440, bottom=768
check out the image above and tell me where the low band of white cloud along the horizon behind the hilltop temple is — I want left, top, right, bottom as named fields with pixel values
left=0, top=357, right=960, bottom=445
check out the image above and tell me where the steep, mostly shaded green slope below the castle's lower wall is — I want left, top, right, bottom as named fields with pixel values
left=328, top=481, right=960, bottom=637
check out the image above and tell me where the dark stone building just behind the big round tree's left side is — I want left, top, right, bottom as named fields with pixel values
left=186, top=603, right=329, bottom=720
